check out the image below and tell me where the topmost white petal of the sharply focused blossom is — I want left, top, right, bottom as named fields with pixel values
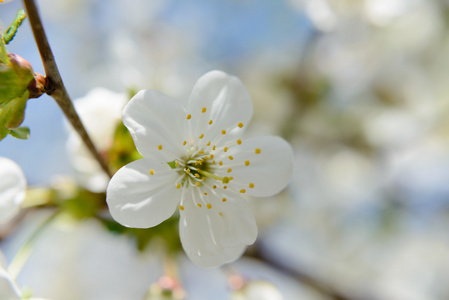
left=187, top=71, right=253, bottom=143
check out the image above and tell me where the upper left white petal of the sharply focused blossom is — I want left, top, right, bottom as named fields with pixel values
left=123, top=90, right=187, bottom=161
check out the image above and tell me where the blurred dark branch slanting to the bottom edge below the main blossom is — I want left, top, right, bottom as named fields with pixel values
left=245, top=246, right=375, bottom=300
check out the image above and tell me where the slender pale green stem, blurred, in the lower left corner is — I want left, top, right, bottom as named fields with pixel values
left=8, top=210, right=59, bottom=279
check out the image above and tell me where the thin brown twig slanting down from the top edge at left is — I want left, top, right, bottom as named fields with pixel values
left=24, top=0, right=112, bottom=177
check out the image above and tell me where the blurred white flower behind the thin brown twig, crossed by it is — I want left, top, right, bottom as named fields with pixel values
left=67, top=88, right=126, bottom=193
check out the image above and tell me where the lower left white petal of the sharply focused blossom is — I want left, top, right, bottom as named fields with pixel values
left=106, top=158, right=181, bottom=228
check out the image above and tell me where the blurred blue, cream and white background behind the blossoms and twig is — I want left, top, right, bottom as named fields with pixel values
left=0, top=0, right=449, bottom=300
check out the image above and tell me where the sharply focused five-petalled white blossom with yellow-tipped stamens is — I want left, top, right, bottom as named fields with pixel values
left=106, top=71, right=293, bottom=267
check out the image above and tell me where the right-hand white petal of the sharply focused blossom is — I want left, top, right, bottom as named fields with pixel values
left=217, top=136, right=293, bottom=197
